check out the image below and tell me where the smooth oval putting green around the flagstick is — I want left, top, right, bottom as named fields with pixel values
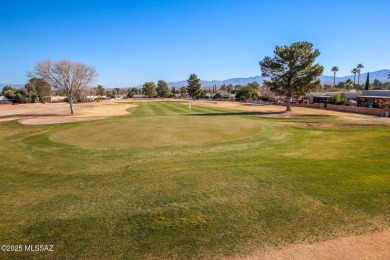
left=51, top=116, right=261, bottom=148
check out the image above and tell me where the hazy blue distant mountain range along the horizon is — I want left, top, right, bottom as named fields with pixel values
left=0, top=69, right=390, bottom=89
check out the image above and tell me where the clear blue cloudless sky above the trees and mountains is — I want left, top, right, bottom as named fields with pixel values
left=0, top=0, right=390, bottom=87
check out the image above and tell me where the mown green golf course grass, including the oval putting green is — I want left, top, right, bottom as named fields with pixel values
left=0, top=102, right=390, bottom=259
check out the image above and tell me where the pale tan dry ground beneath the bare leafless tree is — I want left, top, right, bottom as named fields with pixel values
left=0, top=101, right=137, bottom=125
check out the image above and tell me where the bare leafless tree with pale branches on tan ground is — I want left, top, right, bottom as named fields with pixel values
left=30, top=60, right=97, bottom=115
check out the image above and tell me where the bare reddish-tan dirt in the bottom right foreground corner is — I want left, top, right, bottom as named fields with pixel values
left=236, top=229, right=390, bottom=260
